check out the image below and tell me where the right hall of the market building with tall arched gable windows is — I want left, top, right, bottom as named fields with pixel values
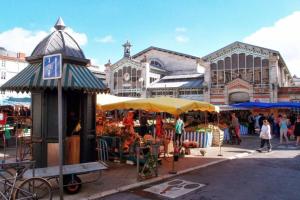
left=202, top=42, right=294, bottom=104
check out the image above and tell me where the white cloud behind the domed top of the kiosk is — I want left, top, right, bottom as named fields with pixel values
left=0, top=27, right=88, bottom=55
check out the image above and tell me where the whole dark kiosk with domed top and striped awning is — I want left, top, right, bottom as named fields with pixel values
left=0, top=18, right=106, bottom=167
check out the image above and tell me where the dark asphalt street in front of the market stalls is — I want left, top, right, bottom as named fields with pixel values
left=103, top=147, right=300, bottom=200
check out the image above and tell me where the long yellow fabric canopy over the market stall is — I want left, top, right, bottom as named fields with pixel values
left=102, top=97, right=219, bottom=115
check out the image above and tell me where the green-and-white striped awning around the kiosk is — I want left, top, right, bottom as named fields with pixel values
left=0, top=63, right=106, bottom=92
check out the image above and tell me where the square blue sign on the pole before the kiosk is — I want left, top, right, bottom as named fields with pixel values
left=43, top=54, right=62, bottom=79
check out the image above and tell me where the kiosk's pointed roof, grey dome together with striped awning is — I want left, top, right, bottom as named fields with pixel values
left=0, top=18, right=107, bottom=92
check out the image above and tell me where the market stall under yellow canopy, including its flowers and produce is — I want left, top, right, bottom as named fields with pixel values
left=98, top=97, right=220, bottom=179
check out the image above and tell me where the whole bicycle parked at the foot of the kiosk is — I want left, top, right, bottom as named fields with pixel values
left=0, top=161, right=52, bottom=200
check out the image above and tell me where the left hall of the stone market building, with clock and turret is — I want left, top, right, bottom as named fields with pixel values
left=105, top=41, right=204, bottom=101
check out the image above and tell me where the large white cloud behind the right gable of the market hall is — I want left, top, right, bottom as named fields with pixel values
left=243, top=11, right=300, bottom=76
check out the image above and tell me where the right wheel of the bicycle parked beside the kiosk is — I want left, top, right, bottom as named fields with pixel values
left=13, top=177, right=52, bottom=199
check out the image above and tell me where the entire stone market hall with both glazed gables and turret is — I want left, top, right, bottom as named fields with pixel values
left=105, top=42, right=300, bottom=105
